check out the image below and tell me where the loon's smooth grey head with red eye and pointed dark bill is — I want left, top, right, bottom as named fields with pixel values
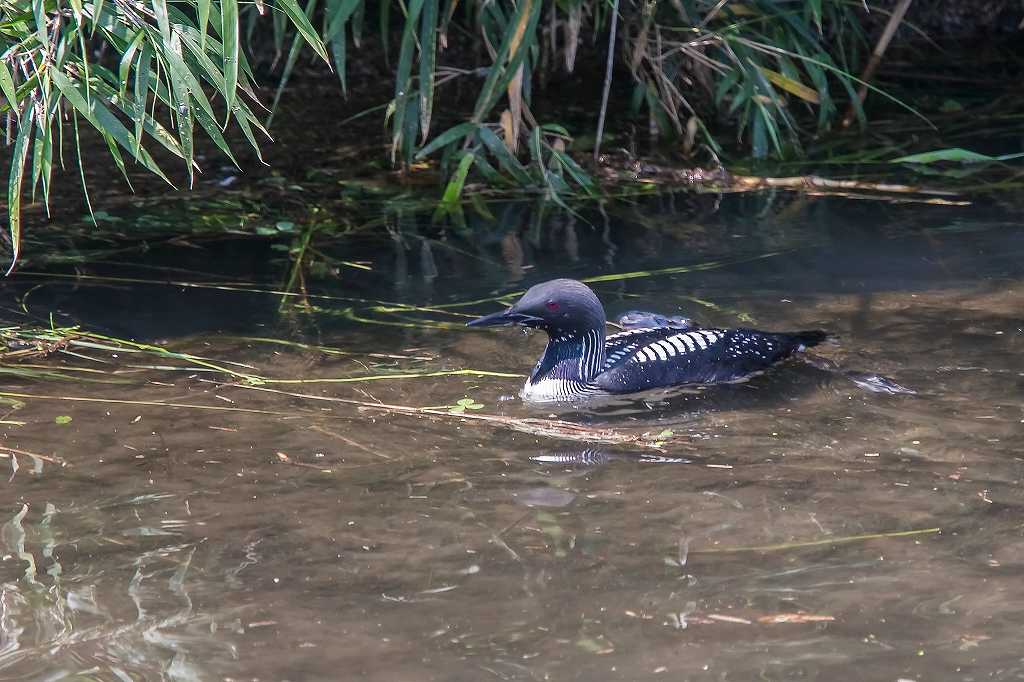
left=469, top=280, right=605, bottom=338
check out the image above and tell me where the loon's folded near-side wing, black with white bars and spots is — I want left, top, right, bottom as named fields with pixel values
left=594, top=328, right=826, bottom=393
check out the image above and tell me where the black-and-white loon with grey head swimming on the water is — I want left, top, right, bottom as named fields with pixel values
left=468, top=280, right=828, bottom=402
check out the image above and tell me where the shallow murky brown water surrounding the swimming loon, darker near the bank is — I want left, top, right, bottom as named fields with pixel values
left=0, top=195, right=1024, bottom=681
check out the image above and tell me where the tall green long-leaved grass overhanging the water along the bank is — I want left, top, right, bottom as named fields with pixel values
left=0, top=0, right=884, bottom=266
